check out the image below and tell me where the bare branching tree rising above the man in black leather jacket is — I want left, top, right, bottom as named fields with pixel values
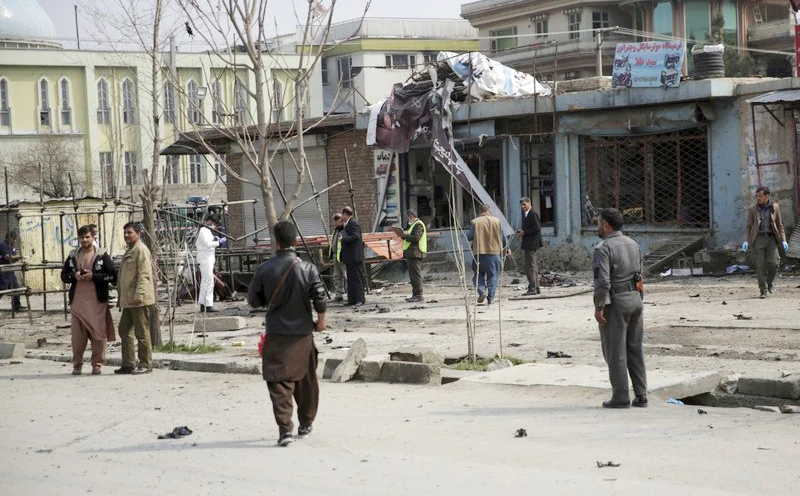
left=179, top=0, right=371, bottom=250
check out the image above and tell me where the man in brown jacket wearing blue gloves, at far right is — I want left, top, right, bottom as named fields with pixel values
left=742, top=186, right=789, bottom=298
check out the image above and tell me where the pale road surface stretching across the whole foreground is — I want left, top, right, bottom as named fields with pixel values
left=0, top=359, right=800, bottom=496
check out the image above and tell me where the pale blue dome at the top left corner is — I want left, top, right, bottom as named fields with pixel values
left=0, top=0, right=61, bottom=48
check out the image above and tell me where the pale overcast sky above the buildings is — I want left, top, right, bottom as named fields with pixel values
left=38, top=0, right=472, bottom=48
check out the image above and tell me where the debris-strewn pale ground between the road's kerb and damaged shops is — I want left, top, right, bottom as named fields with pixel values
left=0, top=272, right=800, bottom=380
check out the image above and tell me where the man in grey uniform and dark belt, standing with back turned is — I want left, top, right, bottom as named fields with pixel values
left=594, top=208, right=647, bottom=408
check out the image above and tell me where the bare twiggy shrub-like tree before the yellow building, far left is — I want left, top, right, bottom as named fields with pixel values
left=11, top=134, right=86, bottom=198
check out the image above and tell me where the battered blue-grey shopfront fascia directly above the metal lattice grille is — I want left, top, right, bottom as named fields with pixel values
left=558, top=103, right=716, bottom=136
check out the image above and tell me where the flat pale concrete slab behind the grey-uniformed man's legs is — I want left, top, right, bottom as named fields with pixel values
left=461, top=363, right=720, bottom=398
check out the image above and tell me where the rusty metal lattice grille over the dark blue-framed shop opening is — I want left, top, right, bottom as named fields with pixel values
left=581, top=127, right=710, bottom=227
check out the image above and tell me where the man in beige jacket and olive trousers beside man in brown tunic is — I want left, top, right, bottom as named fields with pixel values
left=114, top=222, right=156, bottom=374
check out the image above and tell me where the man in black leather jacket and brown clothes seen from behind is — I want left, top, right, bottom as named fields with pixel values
left=247, top=221, right=326, bottom=446
